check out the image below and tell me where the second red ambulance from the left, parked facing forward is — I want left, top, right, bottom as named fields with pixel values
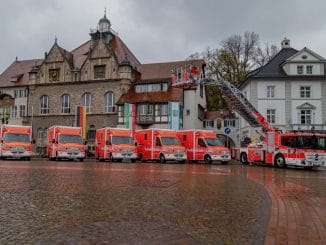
left=47, top=126, right=85, bottom=161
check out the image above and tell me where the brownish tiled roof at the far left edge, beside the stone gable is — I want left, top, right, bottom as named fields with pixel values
left=0, top=59, right=43, bottom=87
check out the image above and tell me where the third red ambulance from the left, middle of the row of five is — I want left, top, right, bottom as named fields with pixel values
left=95, top=128, right=137, bottom=162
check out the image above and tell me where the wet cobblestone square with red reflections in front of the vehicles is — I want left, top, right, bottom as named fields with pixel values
left=0, top=161, right=326, bottom=244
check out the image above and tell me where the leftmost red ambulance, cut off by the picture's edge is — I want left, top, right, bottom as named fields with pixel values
left=0, top=125, right=32, bottom=160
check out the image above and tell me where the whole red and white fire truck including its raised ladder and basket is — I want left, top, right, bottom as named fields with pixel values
left=173, top=66, right=326, bottom=169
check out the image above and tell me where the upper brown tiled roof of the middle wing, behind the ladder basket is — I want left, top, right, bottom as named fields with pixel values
left=137, top=59, right=204, bottom=80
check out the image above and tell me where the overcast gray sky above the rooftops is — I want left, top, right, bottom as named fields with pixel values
left=0, top=0, right=326, bottom=72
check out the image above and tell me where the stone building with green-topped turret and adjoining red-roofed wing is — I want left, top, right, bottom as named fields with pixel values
left=0, top=14, right=206, bottom=154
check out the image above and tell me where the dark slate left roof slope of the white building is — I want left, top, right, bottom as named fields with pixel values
left=248, top=48, right=298, bottom=78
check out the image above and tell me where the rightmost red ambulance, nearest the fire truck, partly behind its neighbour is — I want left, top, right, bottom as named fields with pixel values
left=177, top=129, right=231, bottom=164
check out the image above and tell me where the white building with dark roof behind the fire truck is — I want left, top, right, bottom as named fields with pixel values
left=240, top=38, right=326, bottom=137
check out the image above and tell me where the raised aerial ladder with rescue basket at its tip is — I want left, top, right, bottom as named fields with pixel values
left=172, top=64, right=270, bottom=138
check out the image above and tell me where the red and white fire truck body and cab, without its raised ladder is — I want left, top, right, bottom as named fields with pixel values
left=239, top=131, right=326, bottom=169
